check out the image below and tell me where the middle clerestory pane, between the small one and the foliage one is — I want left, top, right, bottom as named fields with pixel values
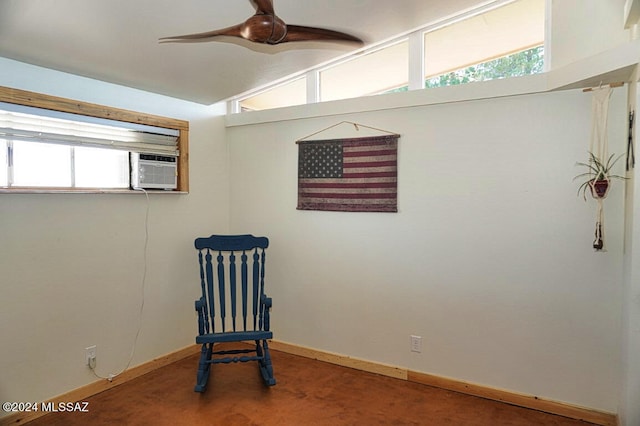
left=320, top=40, right=409, bottom=101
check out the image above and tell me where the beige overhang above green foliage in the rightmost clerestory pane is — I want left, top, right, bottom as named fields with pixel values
left=424, top=0, right=545, bottom=79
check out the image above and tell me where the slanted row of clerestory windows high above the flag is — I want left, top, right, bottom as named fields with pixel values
left=238, top=0, right=546, bottom=111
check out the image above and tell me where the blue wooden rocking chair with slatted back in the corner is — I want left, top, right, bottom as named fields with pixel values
left=194, top=235, right=276, bottom=392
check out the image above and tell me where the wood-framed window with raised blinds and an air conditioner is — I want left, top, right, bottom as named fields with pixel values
left=0, top=87, right=189, bottom=192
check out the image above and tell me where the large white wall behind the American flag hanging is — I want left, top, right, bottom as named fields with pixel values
left=227, top=82, right=626, bottom=412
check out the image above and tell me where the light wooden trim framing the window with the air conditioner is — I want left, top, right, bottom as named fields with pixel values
left=0, top=86, right=189, bottom=192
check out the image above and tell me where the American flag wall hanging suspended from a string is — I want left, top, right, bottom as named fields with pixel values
left=297, top=134, right=399, bottom=212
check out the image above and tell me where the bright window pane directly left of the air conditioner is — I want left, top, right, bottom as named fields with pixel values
left=74, top=147, right=129, bottom=188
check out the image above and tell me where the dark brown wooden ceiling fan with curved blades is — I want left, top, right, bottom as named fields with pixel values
left=160, top=0, right=363, bottom=45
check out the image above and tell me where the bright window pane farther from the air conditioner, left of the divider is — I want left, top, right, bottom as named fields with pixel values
left=13, top=141, right=72, bottom=187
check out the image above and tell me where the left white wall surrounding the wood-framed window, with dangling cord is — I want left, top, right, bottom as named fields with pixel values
left=0, top=59, right=228, bottom=412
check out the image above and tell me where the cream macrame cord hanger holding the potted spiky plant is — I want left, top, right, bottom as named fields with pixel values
left=589, top=85, right=612, bottom=251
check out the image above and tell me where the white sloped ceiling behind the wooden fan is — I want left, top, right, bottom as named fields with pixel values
left=0, top=0, right=487, bottom=104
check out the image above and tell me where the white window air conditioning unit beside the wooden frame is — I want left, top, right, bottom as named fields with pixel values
left=131, top=152, right=178, bottom=190
